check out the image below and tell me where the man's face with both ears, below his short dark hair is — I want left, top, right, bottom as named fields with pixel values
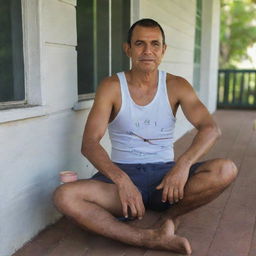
left=125, top=26, right=166, bottom=72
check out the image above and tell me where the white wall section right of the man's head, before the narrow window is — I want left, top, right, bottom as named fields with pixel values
left=140, top=0, right=196, bottom=139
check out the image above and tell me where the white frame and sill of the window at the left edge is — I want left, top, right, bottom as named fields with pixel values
left=0, top=0, right=47, bottom=123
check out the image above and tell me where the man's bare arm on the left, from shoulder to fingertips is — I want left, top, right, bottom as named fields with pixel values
left=81, top=78, right=145, bottom=218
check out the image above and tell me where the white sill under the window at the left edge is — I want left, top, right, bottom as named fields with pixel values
left=0, top=105, right=47, bottom=124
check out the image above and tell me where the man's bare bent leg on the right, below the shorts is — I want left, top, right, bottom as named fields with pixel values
left=163, top=159, right=237, bottom=219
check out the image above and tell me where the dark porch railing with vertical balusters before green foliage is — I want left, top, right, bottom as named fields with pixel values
left=217, top=69, right=256, bottom=109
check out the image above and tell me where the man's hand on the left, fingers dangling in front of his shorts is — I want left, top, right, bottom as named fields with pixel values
left=117, top=179, right=145, bottom=219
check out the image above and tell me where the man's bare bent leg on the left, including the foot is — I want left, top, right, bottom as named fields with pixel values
left=54, top=180, right=191, bottom=254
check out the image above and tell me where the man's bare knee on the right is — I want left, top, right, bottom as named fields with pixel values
left=218, top=159, right=238, bottom=186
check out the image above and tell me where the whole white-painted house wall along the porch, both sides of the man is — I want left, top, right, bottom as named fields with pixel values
left=0, top=0, right=218, bottom=256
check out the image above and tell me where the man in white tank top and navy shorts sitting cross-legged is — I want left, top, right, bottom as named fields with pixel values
left=54, top=19, right=237, bottom=254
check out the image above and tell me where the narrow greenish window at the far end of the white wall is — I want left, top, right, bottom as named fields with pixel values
left=193, top=0, right=202, bottom=91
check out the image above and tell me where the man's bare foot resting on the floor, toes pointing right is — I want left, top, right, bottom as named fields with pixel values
left=149, top=220, right=192, bottom=255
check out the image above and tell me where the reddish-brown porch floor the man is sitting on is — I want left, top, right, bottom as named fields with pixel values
left=13, top=110, right=256, bottom=256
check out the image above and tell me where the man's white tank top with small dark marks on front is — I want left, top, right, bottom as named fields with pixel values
left=108, top=71, right=176, bottom=163
